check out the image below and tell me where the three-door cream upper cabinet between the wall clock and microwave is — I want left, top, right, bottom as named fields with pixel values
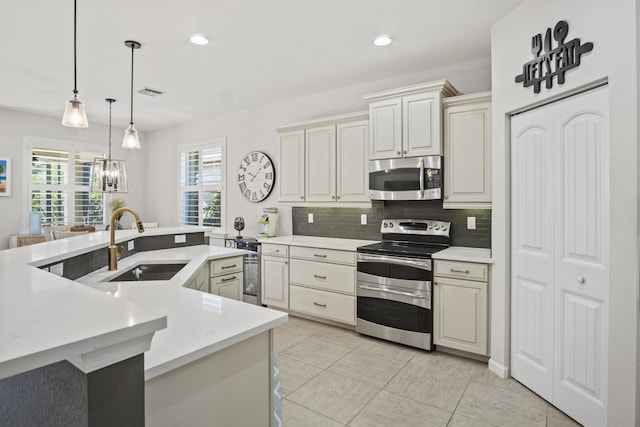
left=277, top=111, right=370, bottom=204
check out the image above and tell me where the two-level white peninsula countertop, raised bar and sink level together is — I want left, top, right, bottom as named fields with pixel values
left=0, top=227, right=287, bottom=379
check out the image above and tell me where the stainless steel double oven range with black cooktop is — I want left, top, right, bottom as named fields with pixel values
left=356, top=219, right=451, bottom=350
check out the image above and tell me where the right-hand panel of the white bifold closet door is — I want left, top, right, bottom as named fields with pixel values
left=554, top=87, right=609, bottom=425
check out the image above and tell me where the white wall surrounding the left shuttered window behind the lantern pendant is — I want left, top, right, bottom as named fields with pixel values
left=0, top=110, right=147, bottom=250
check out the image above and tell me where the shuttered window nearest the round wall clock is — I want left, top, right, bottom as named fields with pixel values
left=178, top=138, right=225, bottom=229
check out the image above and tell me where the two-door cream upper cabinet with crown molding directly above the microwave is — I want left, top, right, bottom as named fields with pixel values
left=364, top=80, right=457, bottom=160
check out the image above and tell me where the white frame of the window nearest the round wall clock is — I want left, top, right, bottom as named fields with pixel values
left=176, top=137, right=227, bottom=233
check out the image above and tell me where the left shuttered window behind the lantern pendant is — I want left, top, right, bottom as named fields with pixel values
left=29, top=141, right=104, bottom=225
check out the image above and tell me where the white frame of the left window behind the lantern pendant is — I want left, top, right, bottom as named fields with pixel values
left=22, top=136, right=108, bottom=230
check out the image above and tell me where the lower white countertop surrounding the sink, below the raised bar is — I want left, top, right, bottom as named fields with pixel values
left=77, top=245, right=287, bottom=380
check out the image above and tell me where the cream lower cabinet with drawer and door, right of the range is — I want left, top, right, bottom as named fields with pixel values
left=433, top=260, right=489, bottom=356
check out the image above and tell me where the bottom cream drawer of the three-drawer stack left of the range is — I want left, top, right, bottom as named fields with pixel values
left=289, top=285, right=356, bottom=325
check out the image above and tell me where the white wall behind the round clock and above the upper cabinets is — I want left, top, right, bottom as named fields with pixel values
left=147, top=58, right=491, bottom=236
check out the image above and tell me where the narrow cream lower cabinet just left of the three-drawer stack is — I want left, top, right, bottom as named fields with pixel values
left=260, top=243, right=289, bottom=309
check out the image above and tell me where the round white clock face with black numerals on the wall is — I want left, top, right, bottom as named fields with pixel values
left=238, top=151, right=276, bottom=202
